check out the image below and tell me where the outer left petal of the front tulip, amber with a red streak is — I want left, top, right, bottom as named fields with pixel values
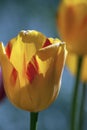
left=0, top=43, right=32, bottom=110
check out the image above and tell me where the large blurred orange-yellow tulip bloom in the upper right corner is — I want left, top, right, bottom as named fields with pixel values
left=57, top=0, right=87, bottom=55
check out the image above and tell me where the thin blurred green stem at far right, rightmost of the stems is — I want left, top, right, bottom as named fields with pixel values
left=78, top=83, right=86, bottom=130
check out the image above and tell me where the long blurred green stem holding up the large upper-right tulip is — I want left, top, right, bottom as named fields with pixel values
left=71, top=56, right=82, bottom=130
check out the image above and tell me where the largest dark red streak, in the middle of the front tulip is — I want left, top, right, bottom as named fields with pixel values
left=26, top=56, right=39, bottom=83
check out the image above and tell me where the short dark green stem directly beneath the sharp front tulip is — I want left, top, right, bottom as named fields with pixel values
left=30, top=112, right=38, bottom=130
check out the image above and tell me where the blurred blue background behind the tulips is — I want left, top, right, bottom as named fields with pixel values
left=0, top=0, right=87, bottom=130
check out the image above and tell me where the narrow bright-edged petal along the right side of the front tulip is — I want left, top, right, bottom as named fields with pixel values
left=49, top=44, right=67, bottom=104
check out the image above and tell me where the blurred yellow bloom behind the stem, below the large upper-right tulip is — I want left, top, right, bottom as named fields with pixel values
left=66, top=53, right=87, bottom=82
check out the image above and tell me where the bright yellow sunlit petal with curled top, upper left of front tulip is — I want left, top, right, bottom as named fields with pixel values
left=6, top=30, right=46, bottom=87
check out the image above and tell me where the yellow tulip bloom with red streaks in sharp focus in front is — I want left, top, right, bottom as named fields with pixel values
left=0, top=30, right=66, bottom=112
